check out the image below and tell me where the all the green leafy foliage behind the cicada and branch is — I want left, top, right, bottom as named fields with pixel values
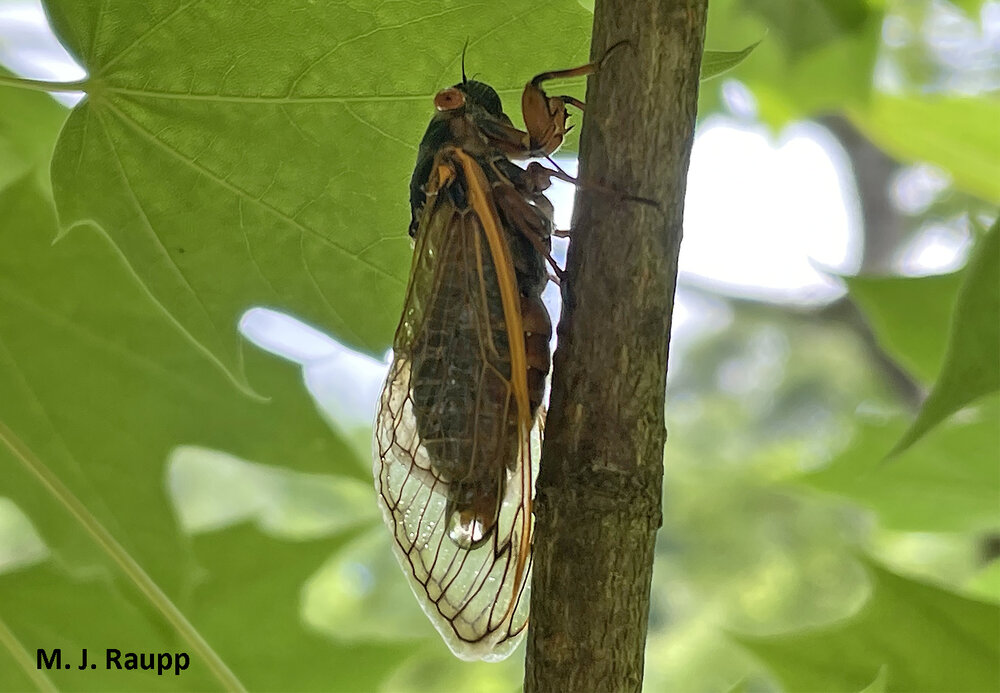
left=0, top=0, right=1000, bottom=691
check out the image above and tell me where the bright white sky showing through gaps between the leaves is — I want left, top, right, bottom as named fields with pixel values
left=0, top=0, right=968, bottom=425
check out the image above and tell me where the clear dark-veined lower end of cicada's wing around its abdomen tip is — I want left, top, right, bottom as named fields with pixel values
left=375, top=359, right=531, bottom=661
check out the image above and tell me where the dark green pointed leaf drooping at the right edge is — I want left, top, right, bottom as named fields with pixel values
left=892, top=219, right=1000, bottom=454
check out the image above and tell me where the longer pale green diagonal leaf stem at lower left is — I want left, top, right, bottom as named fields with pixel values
left=0, top=421, right=246, bottom=691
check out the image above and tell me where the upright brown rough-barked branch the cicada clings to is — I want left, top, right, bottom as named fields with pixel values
left=525, top=0, right=707, bottom=693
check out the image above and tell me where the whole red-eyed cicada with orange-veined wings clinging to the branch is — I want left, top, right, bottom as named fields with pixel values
left=374, top=52, right=596, bottom=661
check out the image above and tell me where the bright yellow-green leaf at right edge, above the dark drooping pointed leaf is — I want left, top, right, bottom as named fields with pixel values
left=849, top=95, right=1000, bottom=202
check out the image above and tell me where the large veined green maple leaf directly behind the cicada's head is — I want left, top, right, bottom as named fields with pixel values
left=47, top=0, right=593, bottom=380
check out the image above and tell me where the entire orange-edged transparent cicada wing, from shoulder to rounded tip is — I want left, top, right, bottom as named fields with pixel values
left=374, top=154, right=539, bottom=660
